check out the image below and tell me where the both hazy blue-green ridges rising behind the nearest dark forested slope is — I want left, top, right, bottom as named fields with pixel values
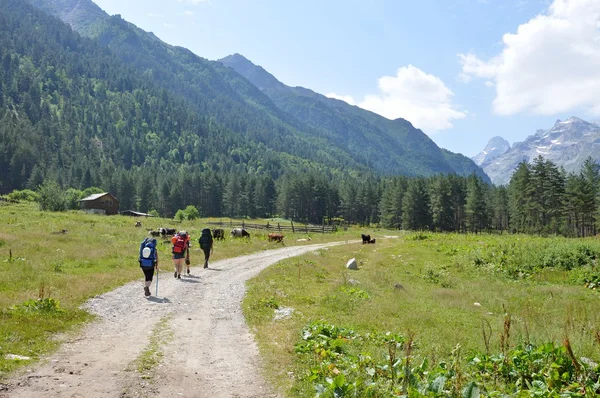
left=28, top=0, right=489, bottom=182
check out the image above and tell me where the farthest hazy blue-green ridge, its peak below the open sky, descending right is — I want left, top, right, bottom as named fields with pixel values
left=220, top=54, right=488, bottom=180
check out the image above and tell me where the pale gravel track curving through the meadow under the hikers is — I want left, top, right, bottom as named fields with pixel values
left=0, top=243, right=340, bottom=398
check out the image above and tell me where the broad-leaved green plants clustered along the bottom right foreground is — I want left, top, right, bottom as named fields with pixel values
left=295, top=321, right=600, bottom=398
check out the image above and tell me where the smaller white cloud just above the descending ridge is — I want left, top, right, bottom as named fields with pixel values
left=344, top=65, right=467, bottom=133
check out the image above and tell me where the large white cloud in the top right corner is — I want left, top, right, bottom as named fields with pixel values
left=459, top=0, right=600, bottom=115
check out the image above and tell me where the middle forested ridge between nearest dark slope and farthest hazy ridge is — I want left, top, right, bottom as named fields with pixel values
left=30, top=0, right=367, bottom=174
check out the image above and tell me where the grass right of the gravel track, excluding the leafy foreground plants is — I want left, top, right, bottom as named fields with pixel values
left=244, top=234, right=600, bottom=396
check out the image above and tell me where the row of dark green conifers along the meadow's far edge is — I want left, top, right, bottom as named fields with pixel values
left=9, top=157, right=600, bottom=237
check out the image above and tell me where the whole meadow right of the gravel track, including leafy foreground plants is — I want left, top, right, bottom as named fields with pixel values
left=244, top=231, right=600, bottom=397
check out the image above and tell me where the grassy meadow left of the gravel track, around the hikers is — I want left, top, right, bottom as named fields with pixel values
left=0, top=202, right=355, bottom=380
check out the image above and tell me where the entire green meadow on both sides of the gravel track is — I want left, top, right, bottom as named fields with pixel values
left=0, top=203, right=600, bottom=397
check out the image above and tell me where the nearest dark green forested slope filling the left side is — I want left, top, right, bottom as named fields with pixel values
left=0, top=0, right=335, bottom=196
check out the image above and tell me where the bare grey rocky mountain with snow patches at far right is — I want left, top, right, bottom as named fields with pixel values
left=473, top=117, right=600, bottom=185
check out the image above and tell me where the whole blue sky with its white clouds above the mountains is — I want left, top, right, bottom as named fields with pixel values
left=95, top=0, right=600, bottom=156
